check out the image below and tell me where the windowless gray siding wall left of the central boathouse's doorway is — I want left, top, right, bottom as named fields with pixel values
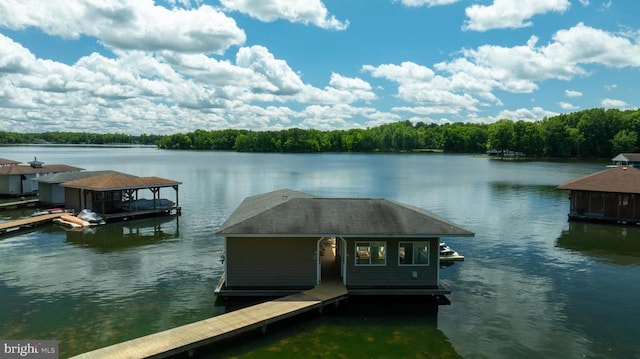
left=225, top=237, right=319, bottom=287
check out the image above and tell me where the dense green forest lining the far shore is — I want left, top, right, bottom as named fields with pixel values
left=0, top=109, right=640, bottom=158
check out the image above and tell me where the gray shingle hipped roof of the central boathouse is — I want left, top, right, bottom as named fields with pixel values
left=217, top=189, right=474, bottom=238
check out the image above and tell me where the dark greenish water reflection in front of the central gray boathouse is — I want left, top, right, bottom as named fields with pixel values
left=197, top=297, right=461, bottom=358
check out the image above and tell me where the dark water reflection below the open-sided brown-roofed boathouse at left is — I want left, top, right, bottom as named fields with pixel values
left=61, top=216, right=180, bottom=253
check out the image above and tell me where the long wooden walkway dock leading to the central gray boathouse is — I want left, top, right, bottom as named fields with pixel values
left=73, top=282, right=348, bottom=359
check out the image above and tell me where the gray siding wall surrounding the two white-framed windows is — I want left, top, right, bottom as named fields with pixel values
left=345, top=238, right=440, bottom=288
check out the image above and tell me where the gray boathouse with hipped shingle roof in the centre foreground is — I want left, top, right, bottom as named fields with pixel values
left=216, top=189, right=474, bottom=296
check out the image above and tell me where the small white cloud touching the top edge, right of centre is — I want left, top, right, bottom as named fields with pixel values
left=463, top=0, right=571, bottom=31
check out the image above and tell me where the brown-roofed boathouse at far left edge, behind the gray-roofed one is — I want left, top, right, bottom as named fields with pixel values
left=0, top=158, right=83, bottom=196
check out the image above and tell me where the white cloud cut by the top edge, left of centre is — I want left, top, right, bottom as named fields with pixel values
left=220, top=0, right=349, bottom=30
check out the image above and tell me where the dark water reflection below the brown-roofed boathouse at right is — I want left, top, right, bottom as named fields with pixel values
left=556, top=222, right=640, bottom=265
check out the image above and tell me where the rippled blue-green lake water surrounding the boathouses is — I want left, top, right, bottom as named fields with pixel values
left=0, top=146, right=640, bottom=358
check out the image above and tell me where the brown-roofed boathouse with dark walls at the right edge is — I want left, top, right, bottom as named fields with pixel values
left=558, top=166, right=640, bottom=224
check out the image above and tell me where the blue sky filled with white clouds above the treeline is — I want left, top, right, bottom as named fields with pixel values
left=0, top=0, right=640, bottom=135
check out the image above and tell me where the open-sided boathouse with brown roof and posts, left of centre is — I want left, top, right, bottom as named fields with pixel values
left=60, top=172, right=182, bottom=221
